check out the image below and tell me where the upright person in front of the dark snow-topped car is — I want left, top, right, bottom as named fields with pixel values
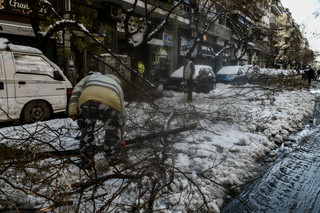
left=183, top=55, right=195, bottom=102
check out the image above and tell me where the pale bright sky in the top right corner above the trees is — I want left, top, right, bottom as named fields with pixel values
left=281, top=0, right=320, bottom=57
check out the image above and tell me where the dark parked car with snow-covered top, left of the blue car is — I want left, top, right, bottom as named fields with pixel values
left=164, top=65, right=216, bottom=93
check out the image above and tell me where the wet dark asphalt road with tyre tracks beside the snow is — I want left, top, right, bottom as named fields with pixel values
left=221, top=88, right=320, bottom=213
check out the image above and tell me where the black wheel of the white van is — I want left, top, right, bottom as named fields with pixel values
left=22, top=101, right=51, bottom=123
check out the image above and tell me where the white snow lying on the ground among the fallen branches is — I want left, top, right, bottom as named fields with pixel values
left=0, top=84, right=314, bottom=213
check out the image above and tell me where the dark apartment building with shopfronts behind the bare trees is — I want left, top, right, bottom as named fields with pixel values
left=0, top=0, right=302, bottom=79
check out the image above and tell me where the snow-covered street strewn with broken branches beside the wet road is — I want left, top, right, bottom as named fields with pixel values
left=0, top=84, right=315, bottom=213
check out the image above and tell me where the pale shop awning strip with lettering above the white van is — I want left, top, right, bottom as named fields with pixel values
left=0, top=20, right=35, bottom=36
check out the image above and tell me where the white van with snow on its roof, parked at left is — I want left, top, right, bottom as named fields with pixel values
left=0, top=38, right=72, bottom=123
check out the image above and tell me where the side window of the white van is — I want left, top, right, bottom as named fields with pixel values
left=14, top=54, right=55, bottom=77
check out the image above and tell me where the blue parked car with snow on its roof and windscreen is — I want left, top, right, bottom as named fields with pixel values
left=216, top=66, right=248, bottom=86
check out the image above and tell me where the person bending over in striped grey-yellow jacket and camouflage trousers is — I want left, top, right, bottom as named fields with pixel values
left=69, top=72, right=126, bottom=169
